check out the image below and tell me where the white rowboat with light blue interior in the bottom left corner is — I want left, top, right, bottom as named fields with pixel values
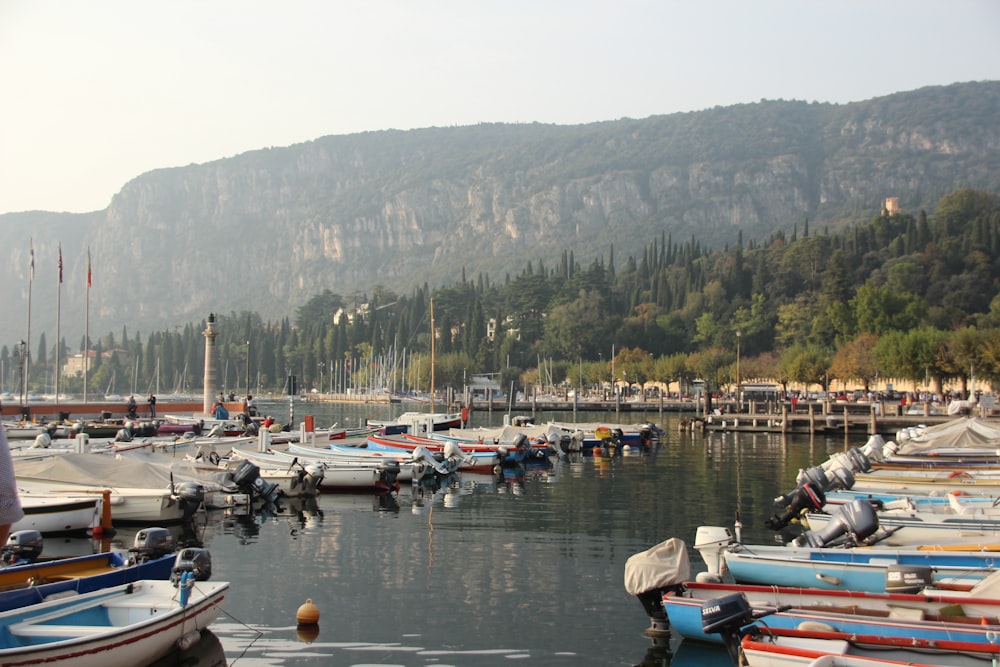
left=0, top=573, right=229, bottom=667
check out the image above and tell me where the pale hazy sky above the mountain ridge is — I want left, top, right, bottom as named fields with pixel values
left=0, top=0, right=1000, bottom=213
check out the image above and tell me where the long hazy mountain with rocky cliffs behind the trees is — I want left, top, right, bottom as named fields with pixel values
left=0, top=82, right=1000, bottom=352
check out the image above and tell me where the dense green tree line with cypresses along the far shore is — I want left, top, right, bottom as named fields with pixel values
left=7, top=189, right=1000, bottom=402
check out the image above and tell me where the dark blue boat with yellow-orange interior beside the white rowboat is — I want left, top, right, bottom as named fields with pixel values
left=0, top=527, right=205, bottom=611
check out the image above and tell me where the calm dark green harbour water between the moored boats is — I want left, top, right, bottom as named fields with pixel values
left=139, top=403, right=863, bottom=667
